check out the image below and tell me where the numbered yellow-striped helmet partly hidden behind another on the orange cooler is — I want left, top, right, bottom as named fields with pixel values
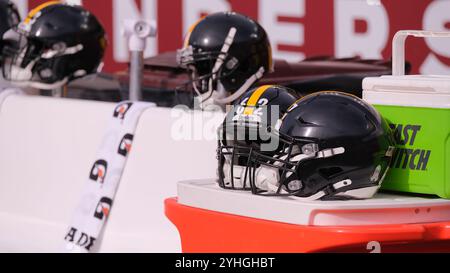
left=217, top=85, right=296, bottom=190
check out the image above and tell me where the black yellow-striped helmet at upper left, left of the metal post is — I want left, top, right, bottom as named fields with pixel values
left=3, top=1, right=107, bottom=90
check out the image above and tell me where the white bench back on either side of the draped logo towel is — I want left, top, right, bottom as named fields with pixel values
left=0, top=96, right=223, bottom=252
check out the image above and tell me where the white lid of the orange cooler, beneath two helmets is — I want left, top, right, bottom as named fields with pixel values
left=178, top=179, right=450, bottom=226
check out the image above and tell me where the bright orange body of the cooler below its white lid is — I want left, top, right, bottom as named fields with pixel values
left=165, top=198, right=450, bottom=253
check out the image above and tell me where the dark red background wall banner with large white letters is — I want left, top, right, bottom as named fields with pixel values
left=19, top=0, right=450, bottom=74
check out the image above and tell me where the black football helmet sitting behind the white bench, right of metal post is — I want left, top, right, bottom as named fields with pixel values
left=177, top=12, right=273, bottom=105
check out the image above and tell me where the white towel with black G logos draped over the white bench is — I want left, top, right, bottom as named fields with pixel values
left=64, top=102, right=154, bottom=253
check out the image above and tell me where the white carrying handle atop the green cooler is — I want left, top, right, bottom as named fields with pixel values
left=392, top=30, right=450, bottom=76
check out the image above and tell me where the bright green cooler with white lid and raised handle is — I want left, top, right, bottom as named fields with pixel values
left=363, top=31, right=450, bottom=199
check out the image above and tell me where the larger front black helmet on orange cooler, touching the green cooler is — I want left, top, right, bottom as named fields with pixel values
left=221, top=92, right=395, bottom=200
